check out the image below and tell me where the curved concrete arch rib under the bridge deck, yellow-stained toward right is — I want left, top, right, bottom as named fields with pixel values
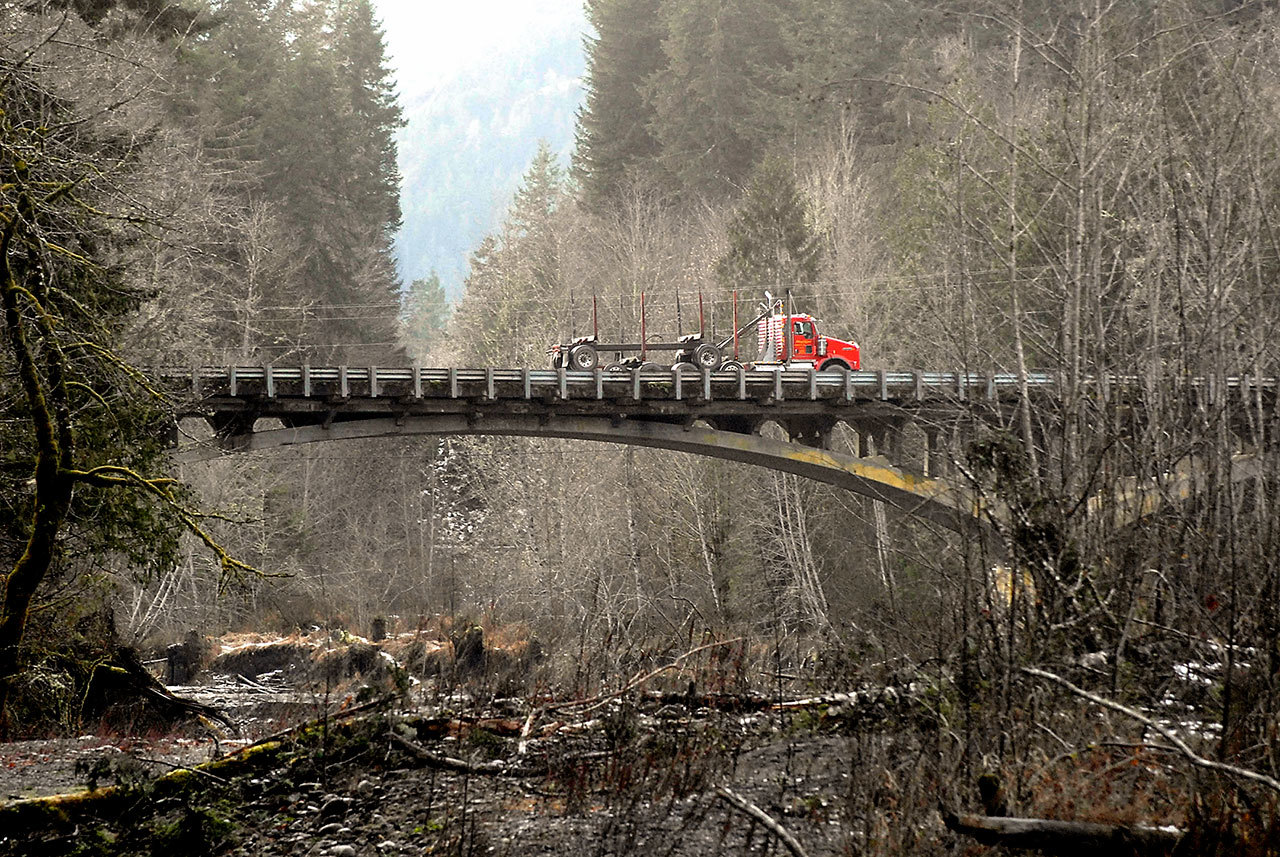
left=175, top=413, right=982, bottom=532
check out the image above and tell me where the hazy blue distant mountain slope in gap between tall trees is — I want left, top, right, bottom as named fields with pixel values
left=397, top=20, right=585, bottom=297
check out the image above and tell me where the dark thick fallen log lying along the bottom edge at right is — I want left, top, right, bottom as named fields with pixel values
left=942, top=810, right=1185, bottom=857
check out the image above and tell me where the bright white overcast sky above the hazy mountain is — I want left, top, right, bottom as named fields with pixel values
left=374, top=0, right=584, bottom=91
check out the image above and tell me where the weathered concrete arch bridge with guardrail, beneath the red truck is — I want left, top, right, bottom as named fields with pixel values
left=163, top=366, right=1275, bottom=531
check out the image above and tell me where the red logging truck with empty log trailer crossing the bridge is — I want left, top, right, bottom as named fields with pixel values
left=547, top=290, right=861, bottom=372
